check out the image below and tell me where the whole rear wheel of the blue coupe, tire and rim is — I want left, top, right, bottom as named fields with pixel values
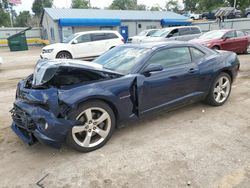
left=206, top=73, right=231, bottom=106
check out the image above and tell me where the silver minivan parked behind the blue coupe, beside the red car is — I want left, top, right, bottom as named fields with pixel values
left=142, top=26, right=201, bottom=42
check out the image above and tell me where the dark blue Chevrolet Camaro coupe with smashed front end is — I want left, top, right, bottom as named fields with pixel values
left=11, top=42, right=240, bottom=152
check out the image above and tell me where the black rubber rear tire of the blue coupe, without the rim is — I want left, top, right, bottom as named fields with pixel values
left=204, top=72, right=232, bottom=106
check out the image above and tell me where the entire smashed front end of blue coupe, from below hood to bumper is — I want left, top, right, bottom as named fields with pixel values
left=11, top=75, right=77, bottom=148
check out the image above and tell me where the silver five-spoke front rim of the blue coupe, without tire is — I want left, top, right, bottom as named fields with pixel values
left=72, top=107, right=111, bottom=148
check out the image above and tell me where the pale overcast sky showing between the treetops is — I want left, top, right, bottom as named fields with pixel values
left=14, top=0, right=182, bottom=12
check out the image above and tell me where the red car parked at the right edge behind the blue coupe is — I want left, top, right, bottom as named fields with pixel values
left=190, top=29, right=250, bottom=53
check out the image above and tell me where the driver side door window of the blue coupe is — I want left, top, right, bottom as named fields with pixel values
left=148, top=47, right=191, bottom=68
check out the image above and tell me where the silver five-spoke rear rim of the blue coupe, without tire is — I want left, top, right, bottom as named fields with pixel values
left=213, top=76, right=231, bottom=103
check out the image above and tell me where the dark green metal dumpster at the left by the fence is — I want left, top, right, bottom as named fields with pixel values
left=7, top=27, right=31, bottom=51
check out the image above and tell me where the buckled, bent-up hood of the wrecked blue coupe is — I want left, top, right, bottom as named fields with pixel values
left=32, top=59, right=122, bottom=87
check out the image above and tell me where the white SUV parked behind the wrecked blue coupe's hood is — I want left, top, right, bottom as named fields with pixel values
left=40, top=30, right=124, bottom=59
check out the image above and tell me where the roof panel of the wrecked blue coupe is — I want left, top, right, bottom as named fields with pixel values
left=123, top=41, right=194, bottom=49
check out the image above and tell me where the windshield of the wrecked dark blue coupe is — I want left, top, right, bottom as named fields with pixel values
left=94, top=46, right=150, bottom=74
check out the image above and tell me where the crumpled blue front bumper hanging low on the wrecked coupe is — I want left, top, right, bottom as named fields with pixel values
left=11, top=100, right=76, bottom=148
